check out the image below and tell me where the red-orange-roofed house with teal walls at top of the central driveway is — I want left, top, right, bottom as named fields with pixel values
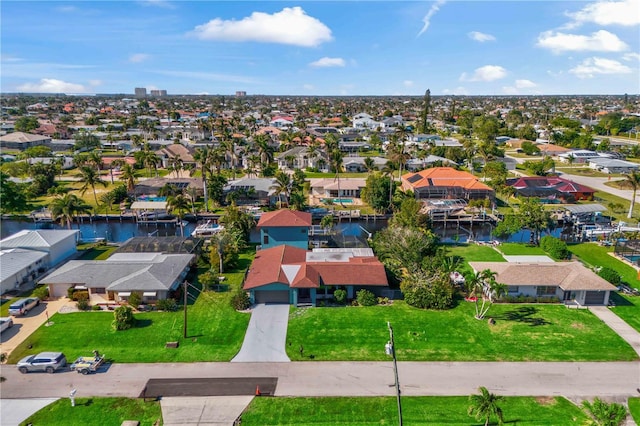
left=243, top=245, right=389, bottom=306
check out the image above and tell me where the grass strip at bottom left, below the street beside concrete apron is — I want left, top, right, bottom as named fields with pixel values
left=20, top=398, right=162, bottom=426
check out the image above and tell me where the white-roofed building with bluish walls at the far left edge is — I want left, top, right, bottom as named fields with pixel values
left=0, top=230, right=80, bottom=294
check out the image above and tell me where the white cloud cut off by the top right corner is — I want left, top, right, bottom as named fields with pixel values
left=566, top=0, right=640, bottom=28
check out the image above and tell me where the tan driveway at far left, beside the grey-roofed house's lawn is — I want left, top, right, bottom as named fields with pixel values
left=0, top=297, right=69, bottom=356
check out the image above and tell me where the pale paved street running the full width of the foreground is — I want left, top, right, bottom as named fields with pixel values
left=2, top=361, right=640, bottom=399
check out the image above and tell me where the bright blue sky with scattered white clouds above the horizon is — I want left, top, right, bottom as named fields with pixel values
left=0, top=0, right=640, bottom=95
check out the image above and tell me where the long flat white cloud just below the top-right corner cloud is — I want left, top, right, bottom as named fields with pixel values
left=536, top=30, right=629, bottom=53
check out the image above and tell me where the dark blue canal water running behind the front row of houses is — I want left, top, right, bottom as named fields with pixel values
left=0, top=219, right=560, bottom=243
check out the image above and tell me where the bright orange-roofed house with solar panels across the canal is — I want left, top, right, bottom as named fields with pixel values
left=401, top=167, right=495, bottom=200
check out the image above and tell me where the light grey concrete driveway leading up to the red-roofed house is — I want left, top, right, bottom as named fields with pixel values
left=231, top=304, right=291, bottom=362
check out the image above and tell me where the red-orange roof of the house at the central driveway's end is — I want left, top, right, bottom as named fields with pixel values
left=243, top=245, right=389, bottom=290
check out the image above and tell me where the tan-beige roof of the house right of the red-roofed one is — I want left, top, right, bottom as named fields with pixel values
left=469, top=262, right=616, bottom=291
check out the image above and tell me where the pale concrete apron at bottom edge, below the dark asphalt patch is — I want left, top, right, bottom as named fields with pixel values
left=160, top=396, right=253, bottom=426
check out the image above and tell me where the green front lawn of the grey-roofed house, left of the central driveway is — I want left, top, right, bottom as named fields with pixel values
left=9, top=251, right=255, bottom=363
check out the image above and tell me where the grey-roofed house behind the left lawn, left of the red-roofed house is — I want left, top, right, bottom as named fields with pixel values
left=40, top=253, right=195, bottom=303
